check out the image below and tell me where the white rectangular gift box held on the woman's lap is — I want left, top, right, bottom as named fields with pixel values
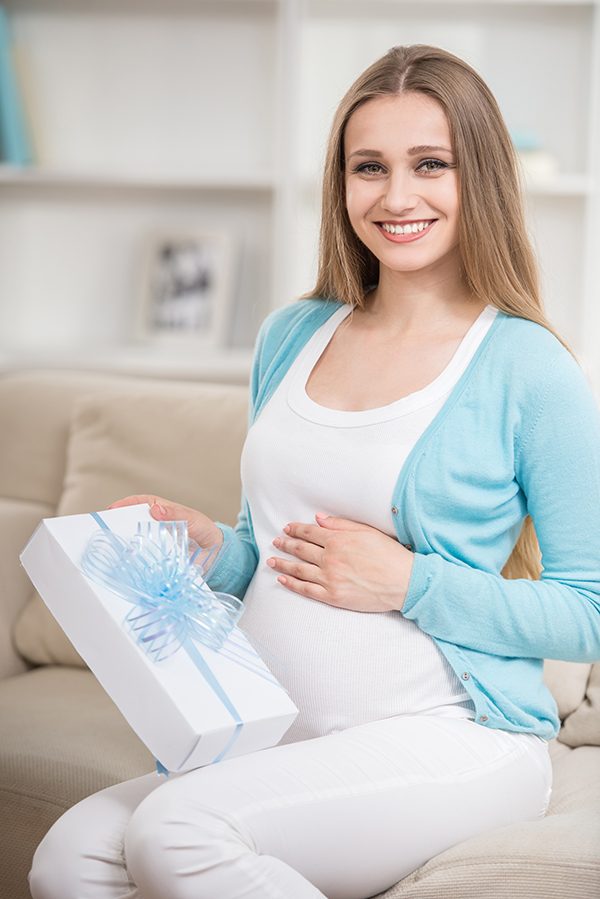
left=21, top=505, right=298, bottom=771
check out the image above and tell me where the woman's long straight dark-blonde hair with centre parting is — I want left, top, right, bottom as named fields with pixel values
left=306, top=44, right=564, bottom=580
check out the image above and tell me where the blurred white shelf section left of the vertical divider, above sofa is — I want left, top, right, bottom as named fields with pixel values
left=0, top=0, right=281, bottom=381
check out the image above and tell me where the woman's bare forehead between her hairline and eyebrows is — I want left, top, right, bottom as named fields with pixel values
left=344, top=91, right=452, bottom=153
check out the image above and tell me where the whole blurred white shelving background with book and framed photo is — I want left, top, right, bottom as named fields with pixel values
left=0, top=0, right=600, bottom=395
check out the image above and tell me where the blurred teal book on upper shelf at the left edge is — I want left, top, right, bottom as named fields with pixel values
left=0, top=6, right=33, bottom=165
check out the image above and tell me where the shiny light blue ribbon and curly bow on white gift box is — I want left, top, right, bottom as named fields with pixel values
left=81, top=512, right=250, bottom=772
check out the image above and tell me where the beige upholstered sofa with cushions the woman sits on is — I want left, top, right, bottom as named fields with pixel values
left=0, top=372, right=600, bottom=899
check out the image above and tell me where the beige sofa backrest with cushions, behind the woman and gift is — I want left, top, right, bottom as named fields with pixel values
left=0, top=373, right=600, bottom=746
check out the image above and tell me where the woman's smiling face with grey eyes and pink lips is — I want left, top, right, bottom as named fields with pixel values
left=344, top=92, right=460, bottom=284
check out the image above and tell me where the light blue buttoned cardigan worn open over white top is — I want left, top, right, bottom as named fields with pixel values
left=209, top=300, right=600, bottom=739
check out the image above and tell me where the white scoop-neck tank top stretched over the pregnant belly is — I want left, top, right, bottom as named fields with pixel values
left=240, top=306, right=496, bottom=743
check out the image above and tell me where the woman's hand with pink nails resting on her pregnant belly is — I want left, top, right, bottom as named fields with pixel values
left=267, top=513, right=414, bottom=612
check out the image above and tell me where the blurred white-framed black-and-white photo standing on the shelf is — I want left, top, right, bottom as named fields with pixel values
left=136, top=228, right=233, bottom=346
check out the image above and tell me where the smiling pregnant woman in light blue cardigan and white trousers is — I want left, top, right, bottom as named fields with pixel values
left=31, top=46, right=600, bottom=899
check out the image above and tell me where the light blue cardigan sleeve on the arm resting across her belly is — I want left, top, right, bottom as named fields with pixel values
left=402, top=353, right=600, bottom=662
